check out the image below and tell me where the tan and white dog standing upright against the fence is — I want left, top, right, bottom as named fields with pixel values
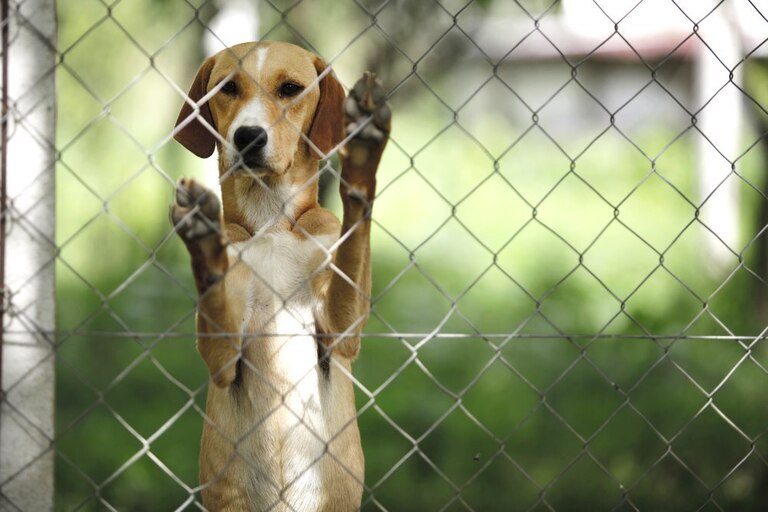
left=171, top=42, right=390, bottom=512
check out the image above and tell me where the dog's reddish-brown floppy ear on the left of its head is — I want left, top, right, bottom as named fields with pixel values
left=174, top=57, right=216, bottom=158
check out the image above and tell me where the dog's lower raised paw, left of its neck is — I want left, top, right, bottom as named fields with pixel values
left=171, top=178, right=221, bottom=245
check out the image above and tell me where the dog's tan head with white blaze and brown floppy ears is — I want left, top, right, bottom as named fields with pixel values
left=175, top=42, right=344, bottom=177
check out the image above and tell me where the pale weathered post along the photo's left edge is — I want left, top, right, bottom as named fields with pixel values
left=0, top=0, right=56, bottom=511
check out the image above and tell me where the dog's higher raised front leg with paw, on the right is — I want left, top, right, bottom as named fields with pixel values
left=325, top=72, right=392, bottom=357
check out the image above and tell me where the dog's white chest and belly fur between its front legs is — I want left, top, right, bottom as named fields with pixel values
left=228, top=232, right=333, bottom=511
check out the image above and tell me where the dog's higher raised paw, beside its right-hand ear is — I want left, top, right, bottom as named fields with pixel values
left=344, top=71, right=392, bottom=142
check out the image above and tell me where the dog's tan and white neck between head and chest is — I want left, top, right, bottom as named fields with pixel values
left=221, top=161, right=318, bottom=236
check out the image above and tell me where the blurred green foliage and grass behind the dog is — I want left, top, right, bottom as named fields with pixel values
left=56, top=0, right=768, bottom=511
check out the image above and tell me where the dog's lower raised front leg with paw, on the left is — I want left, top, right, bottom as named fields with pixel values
left=171, top=179, right=242, bottom=387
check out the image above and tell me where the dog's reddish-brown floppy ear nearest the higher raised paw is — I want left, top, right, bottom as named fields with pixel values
left=307, top=57, right=344, bottom=160
